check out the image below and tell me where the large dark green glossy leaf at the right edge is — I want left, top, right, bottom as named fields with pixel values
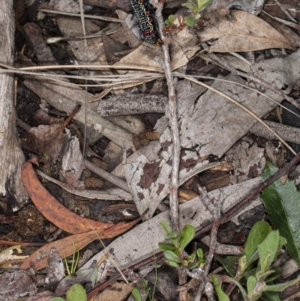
left=261, top=163, right=300, bottom=267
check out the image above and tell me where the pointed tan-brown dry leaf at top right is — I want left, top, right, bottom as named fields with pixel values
left=197, top=9, right=294, bottom=52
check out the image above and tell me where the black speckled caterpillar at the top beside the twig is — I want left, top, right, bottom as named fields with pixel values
left=130, top=0, right=162, bottom=45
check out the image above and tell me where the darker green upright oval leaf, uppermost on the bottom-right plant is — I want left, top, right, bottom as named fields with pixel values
left=244, top=221, right=272, bottom=261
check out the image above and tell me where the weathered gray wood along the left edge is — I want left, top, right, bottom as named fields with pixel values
left=0, top=0, right=28, bottom=205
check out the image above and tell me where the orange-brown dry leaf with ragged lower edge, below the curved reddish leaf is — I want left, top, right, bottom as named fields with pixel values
left=20, top=219, right=140, bottom=270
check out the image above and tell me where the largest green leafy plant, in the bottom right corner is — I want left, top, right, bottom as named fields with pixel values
left=212, top=221, right=300, bottom=301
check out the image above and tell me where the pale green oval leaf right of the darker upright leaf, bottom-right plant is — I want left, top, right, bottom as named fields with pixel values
left=258, top=230, right=279, bottom=272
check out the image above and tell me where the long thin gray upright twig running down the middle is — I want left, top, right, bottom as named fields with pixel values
left=150, top=0, right=180, bottom=231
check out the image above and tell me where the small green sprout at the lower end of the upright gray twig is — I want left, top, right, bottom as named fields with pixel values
left=158, top=221, right=206, bottom=270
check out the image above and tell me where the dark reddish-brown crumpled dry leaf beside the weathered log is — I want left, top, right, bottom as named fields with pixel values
left=22, top=122, right=64, bottom=164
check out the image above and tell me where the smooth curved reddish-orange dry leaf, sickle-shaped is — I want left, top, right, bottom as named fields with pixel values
left=22, top=160, right=136, bottom=233
